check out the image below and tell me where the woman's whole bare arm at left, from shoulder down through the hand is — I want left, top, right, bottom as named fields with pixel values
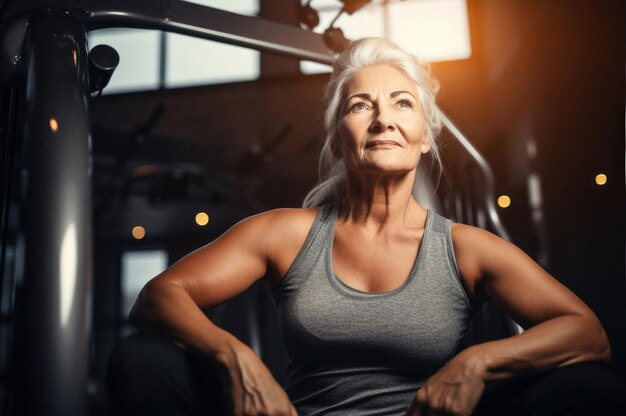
left=130, top=211, right=296, bottom=416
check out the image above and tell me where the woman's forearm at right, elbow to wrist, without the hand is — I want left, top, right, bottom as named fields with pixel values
left=459, top=315, right=611, bottom=381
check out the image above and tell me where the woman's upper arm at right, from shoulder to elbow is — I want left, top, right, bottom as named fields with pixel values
left=450, top=226, right=595, bottom=329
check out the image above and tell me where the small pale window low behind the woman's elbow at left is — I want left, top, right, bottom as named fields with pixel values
left=120, top=250, right=167, bottom=317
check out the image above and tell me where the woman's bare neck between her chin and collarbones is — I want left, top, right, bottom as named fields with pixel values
left=339, top=172, right=426, bottom=231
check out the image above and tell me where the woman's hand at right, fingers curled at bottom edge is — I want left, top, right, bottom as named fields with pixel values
left=406, top=353, right=485, bottom=416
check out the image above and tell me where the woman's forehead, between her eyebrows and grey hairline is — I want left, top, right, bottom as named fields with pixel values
left=346, top=65, right=417, bottom=97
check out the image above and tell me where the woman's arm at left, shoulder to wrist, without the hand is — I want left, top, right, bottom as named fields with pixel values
left=130, top=213, right=272, bottom=358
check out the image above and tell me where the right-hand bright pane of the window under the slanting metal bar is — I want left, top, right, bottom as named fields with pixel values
left=165, top=33, right=260, bottom=88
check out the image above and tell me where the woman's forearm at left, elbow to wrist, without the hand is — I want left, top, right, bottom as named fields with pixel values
left=129, top=281, right=241, bottom=359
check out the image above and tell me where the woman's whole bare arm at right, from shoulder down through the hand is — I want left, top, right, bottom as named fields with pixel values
left=407, top=224, right=611, bottom=416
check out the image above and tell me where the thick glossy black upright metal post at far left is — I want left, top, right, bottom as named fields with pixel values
left=14, top=15, right=92, bottom=416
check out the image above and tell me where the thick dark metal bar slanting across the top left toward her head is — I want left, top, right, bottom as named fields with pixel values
left=3, top=0, right=333, bottom=64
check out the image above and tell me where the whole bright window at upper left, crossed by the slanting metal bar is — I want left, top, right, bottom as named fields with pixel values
left=88, top=0, right=260, bottom=94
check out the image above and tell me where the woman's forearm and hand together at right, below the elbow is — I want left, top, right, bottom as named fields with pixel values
left=407, top=313, right=611, bottom=416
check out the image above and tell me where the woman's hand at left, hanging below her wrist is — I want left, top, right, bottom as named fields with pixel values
left=216, top=343, right=298, bottom=416
